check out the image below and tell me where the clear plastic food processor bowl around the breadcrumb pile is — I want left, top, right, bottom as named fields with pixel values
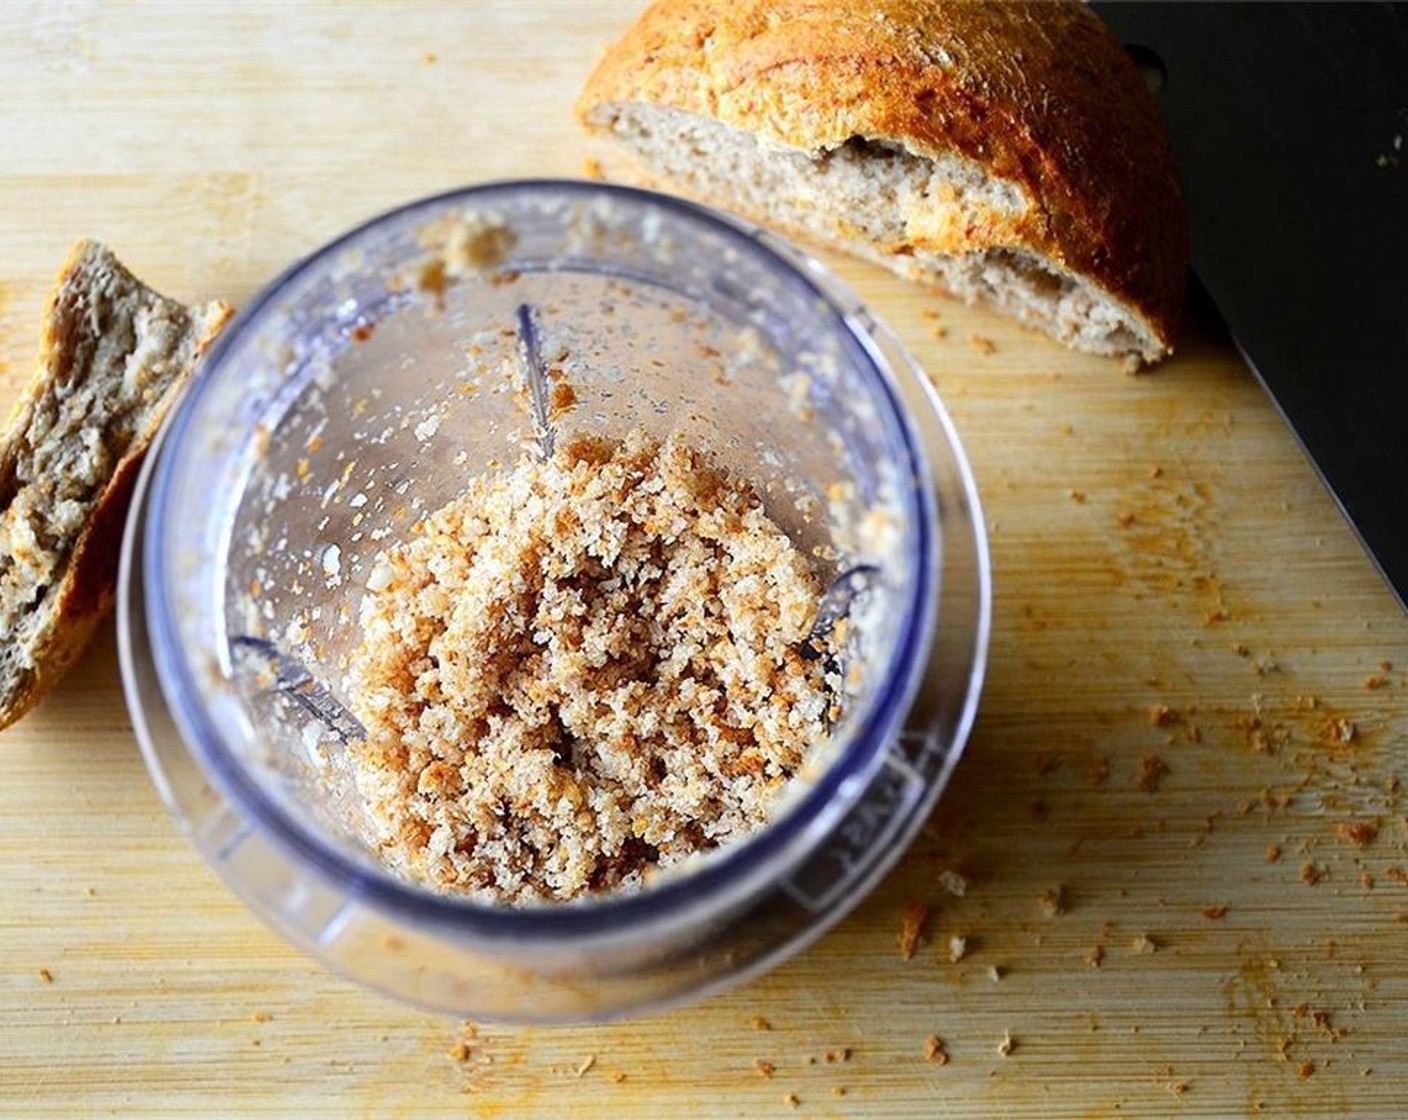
left=118, top=182, right=990, bottom=1021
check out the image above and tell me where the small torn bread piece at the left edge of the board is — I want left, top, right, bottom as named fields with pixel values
left=0, top=241, right=231, bottom=727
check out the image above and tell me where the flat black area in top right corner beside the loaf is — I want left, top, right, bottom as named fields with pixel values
left=1091, top=3, right=1408, bottom=607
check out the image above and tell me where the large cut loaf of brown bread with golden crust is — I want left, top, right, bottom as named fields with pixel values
left=577, top=0, right=1188, bottom=363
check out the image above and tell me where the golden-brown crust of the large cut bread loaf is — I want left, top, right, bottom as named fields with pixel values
left=577, top=0, right=1188, bottom=349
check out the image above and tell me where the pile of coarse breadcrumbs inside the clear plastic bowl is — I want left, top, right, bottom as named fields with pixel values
left=346, top=431, right=834, bottom=903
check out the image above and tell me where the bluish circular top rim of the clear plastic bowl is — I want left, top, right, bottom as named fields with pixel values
left=142, top=180, right=939, bottom=944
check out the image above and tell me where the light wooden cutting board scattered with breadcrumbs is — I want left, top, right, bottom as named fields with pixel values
left=0, top=0, right=1408, bottom=1119
